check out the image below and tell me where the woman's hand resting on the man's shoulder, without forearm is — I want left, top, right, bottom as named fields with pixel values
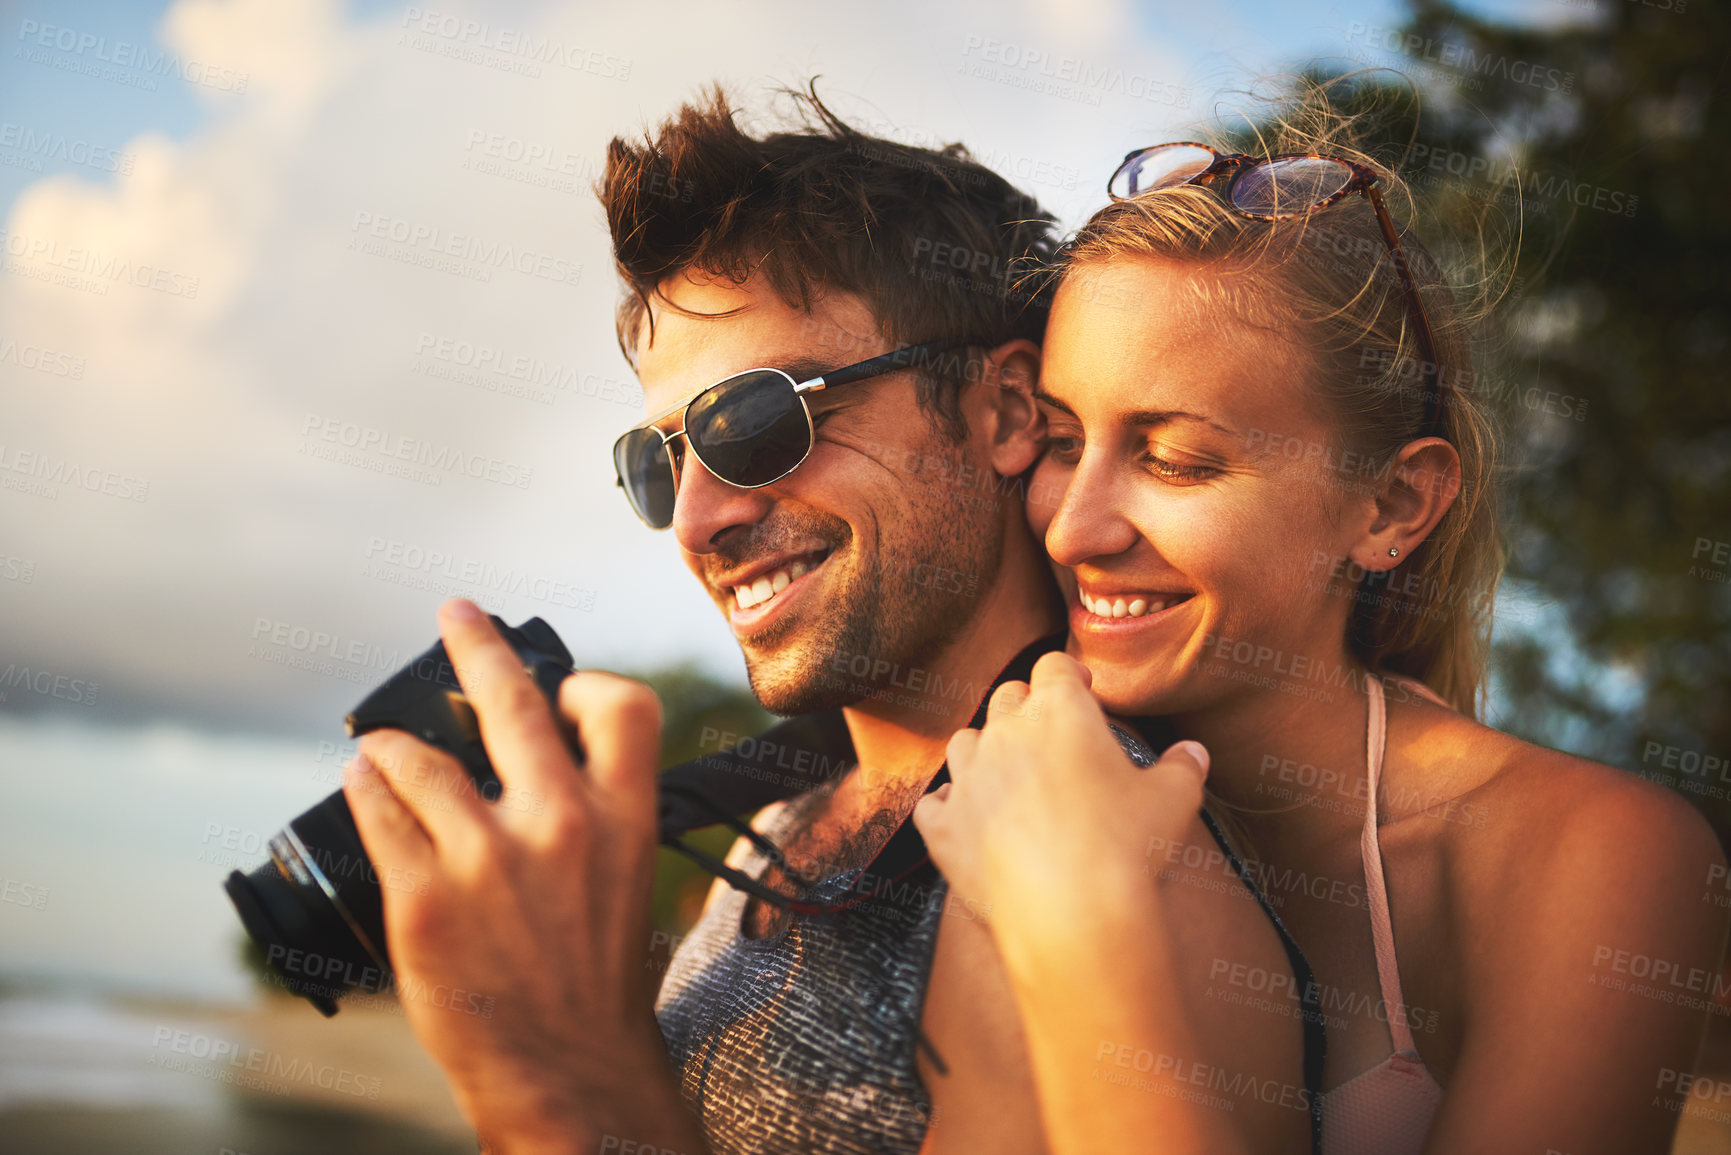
left=914, top=653, right=1208, bottom=966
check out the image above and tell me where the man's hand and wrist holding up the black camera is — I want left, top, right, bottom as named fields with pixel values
left=343, top=601, right=703, bottom=1155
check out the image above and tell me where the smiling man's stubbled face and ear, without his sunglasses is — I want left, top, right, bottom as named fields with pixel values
left=635, top=266, right=1058, bottom=754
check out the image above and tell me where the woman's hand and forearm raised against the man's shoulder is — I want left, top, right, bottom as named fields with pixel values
left=914, top=653, right=1252, bottom=1155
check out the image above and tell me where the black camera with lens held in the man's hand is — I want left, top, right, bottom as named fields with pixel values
left=223, top=616, right=571, bottom=1015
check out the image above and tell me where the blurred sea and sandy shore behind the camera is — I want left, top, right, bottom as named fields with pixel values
left=0, top=717, right=474, bottom=1155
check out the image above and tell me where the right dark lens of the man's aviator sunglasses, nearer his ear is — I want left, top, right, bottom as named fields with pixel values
left=685, top=369, right=812, bottom=487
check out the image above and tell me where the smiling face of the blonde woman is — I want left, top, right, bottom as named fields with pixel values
left=1028, top=258, right=1376, bottom=713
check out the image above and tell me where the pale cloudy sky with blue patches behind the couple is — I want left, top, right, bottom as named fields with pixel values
left=0, top=0, right=1570, bottom=732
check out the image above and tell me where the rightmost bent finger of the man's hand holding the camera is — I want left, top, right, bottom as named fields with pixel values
left=559, top=670, right=661, bottom=823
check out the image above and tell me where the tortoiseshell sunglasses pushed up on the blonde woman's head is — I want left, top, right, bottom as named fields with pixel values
left=1106, top=140, right=1442, bottom=436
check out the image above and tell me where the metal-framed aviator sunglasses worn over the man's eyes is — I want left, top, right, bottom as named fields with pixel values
left=613, top=338, right=973, bottom=530
